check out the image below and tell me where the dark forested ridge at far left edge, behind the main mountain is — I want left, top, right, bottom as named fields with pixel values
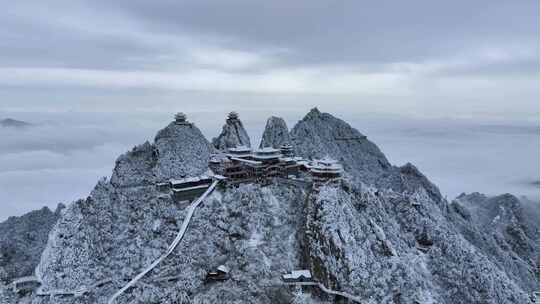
left=0, top=205, right=64, bottom=283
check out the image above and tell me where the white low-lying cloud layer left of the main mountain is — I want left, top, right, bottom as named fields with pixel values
left=0, top=115, right=153, bottom=220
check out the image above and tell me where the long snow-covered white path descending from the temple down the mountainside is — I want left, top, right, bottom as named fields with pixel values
left=108, top=180, right=220, bottom=304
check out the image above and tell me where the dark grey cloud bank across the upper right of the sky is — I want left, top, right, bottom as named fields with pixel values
left=88, top=0, right=540, bottom=62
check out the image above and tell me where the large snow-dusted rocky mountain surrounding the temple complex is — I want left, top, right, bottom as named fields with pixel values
left=2, top=109, right=539, bottom=304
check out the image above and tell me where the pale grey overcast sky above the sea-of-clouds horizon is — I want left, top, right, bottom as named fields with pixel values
left=0, top=0, right=540, bottom=115
